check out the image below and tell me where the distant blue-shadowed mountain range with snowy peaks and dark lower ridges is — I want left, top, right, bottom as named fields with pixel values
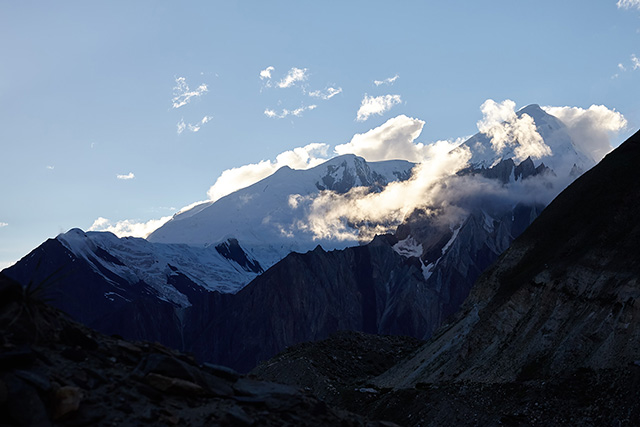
left=4, top=105, right=594, bottom=370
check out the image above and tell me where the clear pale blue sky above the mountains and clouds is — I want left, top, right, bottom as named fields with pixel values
left=0, top=0, right=640, bottom=268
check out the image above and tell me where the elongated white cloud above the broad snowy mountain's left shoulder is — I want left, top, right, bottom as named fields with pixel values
left=207, top=143, right=329, bottom=201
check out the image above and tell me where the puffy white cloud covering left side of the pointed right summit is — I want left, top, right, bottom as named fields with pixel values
left=477, top=99, right=552, bottom=161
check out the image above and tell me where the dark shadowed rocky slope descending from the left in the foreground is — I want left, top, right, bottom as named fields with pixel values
left=0, top=275, right=392, bottom=426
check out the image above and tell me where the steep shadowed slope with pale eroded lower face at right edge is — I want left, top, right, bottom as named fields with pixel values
left=378, top=129, right=640, bottom=387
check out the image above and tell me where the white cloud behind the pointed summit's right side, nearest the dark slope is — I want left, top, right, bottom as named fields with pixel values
left=542, top=105, right=627, bottom=162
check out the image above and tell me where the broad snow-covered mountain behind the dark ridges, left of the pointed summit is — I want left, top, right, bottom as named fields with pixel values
left=148, top=154, right=414, bottom=254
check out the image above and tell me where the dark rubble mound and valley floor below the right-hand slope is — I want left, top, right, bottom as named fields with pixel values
left=252, top=332, right=640, bottom=426
